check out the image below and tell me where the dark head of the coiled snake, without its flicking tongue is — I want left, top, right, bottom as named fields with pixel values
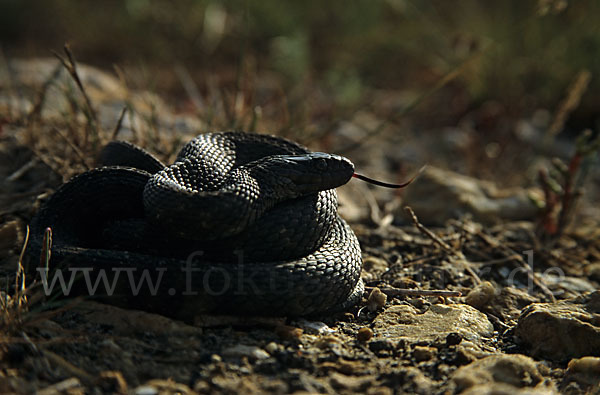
left=257, top=152, right=354, bottom=195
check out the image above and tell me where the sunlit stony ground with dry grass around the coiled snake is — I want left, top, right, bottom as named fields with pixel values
left=0, top=60, right=600, bottom=394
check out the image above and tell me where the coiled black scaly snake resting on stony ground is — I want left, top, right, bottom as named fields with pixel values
left=29, top=132, right=364, bottom=318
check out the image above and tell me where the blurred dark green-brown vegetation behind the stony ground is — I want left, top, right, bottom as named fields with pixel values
left=0, top=0, right=600, bottom=132
